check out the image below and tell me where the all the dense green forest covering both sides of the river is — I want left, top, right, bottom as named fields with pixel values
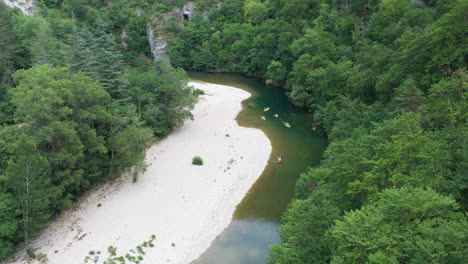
left=0, top=0, right=468, bottom=264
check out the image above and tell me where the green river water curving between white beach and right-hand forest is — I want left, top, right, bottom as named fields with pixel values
left=189, top=72, right=327, bottom=264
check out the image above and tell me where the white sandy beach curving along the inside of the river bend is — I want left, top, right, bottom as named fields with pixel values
left=4, top=83, right=271, bottom=264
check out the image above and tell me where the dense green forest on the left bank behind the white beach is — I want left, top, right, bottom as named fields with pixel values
left=0, top=1, right=196, bottom=260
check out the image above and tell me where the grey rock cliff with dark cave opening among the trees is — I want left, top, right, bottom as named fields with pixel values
left=146, top=2, right=197, bottom=60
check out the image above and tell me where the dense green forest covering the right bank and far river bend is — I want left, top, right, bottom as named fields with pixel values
left=170, top=0, right=468, bottom=264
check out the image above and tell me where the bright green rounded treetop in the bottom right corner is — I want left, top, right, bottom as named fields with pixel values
left=329, top=187, right=468, bottom=263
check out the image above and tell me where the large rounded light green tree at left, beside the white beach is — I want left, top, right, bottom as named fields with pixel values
left=12, top=65, right=110, bottom=208
